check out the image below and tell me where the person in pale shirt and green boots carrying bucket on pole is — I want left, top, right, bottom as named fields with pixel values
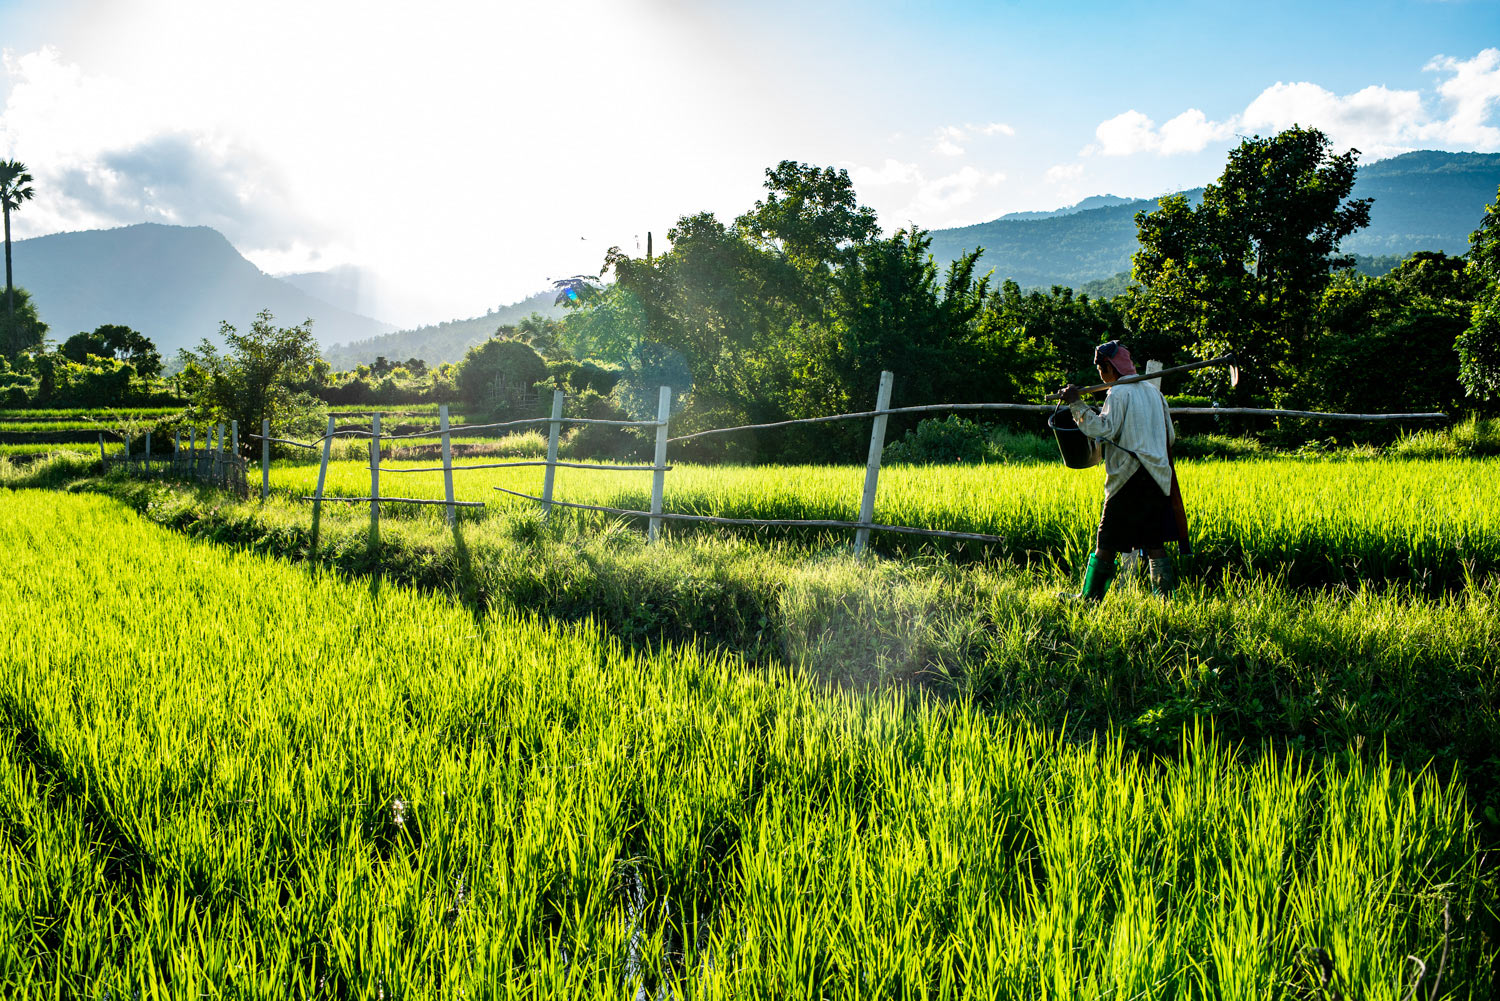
left=1058, top=341, right=1191, bottom=602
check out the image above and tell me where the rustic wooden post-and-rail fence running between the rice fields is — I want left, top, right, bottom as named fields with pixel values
left=126, top=372, right=1448, bottom=552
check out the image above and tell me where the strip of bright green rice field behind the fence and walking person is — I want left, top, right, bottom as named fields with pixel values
left=272, top=458, right=1500, bottom=591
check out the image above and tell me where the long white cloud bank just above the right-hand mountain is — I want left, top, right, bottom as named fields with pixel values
left=1083, top=48, right=1500, bottom=159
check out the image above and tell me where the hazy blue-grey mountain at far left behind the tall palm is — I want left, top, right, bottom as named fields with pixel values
left=12, top=222, right=392, bottom=356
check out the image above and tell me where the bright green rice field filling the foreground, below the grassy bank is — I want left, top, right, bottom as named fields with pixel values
left=0, top=491, right=1496, bottom=999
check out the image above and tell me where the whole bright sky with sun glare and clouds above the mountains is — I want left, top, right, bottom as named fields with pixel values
left=0, top=0, right=1500, bottom=323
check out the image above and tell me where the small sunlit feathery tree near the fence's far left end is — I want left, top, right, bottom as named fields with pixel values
left=179, top=309, right=323, bottom=447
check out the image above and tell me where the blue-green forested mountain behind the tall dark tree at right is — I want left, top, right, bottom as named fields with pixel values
left=932, top=150, right=1500, bottom=288
